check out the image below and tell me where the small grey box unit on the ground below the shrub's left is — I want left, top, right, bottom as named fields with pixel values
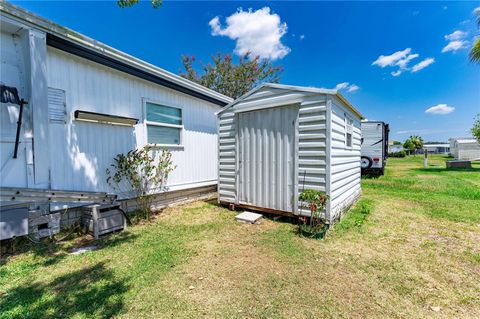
left=82, top=204, right=127, bottom=239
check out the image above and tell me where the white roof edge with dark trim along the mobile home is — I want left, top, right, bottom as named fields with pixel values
left=0, top=1, right=232, bottom=106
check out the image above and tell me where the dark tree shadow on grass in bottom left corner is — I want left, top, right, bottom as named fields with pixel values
left=0, top=263, right=128, bottom=318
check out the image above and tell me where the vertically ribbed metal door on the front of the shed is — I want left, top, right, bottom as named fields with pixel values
left=238, top=106, right=298, bottom=212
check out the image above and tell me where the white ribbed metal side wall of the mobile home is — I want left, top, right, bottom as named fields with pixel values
left=45, top=47, right=220, bottom=191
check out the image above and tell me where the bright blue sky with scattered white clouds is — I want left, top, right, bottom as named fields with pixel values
left=13, top=1, right=480, bottom=141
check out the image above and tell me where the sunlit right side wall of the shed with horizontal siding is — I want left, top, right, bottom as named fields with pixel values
left=330, top=97, right=362, bottom=220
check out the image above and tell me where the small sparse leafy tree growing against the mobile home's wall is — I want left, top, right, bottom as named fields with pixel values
left=106, top=146, right=176, bottom=219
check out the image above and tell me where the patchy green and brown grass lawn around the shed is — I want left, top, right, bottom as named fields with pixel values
left=0, top=157, right=480, bottom=318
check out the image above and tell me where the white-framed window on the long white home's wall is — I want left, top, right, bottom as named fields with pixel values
left=146, top=102, right=183, bottom=145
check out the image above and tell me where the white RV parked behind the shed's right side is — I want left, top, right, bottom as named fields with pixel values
left=361, top=121, right=390, bottom=175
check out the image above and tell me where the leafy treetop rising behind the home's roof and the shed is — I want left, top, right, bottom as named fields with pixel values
left=180, top=53, right=283, bottom=98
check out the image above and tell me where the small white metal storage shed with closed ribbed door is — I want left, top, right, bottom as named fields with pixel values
left=217, top=83, right=363, bottom=223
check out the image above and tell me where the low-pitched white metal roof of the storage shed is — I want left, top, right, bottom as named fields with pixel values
left=217, top=83, right=364, bottom=119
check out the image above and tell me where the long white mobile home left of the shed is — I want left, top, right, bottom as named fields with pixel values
left=0, top=2, right=231, bottom=208
